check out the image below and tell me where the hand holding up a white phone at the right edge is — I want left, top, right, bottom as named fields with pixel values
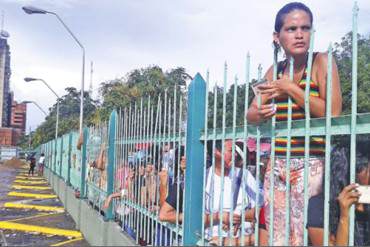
left=337, top=184, right=361, bottom=216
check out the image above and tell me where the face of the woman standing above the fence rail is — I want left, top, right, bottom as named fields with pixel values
left=274, top=10, right=311, bottom=57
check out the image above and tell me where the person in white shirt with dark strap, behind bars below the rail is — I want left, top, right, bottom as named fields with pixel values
left=204, top=140, right=255, bottom=245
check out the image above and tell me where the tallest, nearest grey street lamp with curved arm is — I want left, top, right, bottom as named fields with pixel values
left=22, top=6, right=85, bottom=133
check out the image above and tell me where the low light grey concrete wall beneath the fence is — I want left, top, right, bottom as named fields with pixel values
left=44, top=169, right=135, bottom=246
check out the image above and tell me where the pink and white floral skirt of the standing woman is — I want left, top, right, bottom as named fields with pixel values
left=264, top=158, right=325, bottom=246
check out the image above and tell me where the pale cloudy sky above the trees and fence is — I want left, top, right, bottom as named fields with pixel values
left=0, top=0, right=370, bottom=131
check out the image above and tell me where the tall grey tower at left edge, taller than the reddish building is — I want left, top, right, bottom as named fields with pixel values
left=0, top=30, right=12, bottom=127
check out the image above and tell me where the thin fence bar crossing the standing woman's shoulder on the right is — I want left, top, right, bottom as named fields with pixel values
left=323, top=44, right=333, bottom=246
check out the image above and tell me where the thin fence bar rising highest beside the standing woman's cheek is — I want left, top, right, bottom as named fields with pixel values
left=302, top=27, right=315, bottom=245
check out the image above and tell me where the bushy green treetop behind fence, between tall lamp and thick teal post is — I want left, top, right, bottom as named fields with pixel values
left=94, top=66, right=191, bottom=133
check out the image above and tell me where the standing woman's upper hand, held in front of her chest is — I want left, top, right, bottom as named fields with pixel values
left=258, top=75, right=295, bottom=100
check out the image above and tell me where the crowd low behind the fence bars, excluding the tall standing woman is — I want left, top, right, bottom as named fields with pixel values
left=97, top=135, right=370, bottom=246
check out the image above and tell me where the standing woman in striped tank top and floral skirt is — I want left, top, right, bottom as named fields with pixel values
left=247, top=2, right=342, bottom=245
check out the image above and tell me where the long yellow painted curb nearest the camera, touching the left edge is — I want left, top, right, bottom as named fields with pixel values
left=0, top=221, right=82, bottom=238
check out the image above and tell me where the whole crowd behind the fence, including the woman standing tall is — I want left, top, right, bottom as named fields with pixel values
left=99, top=2, right=370, bottom=245
